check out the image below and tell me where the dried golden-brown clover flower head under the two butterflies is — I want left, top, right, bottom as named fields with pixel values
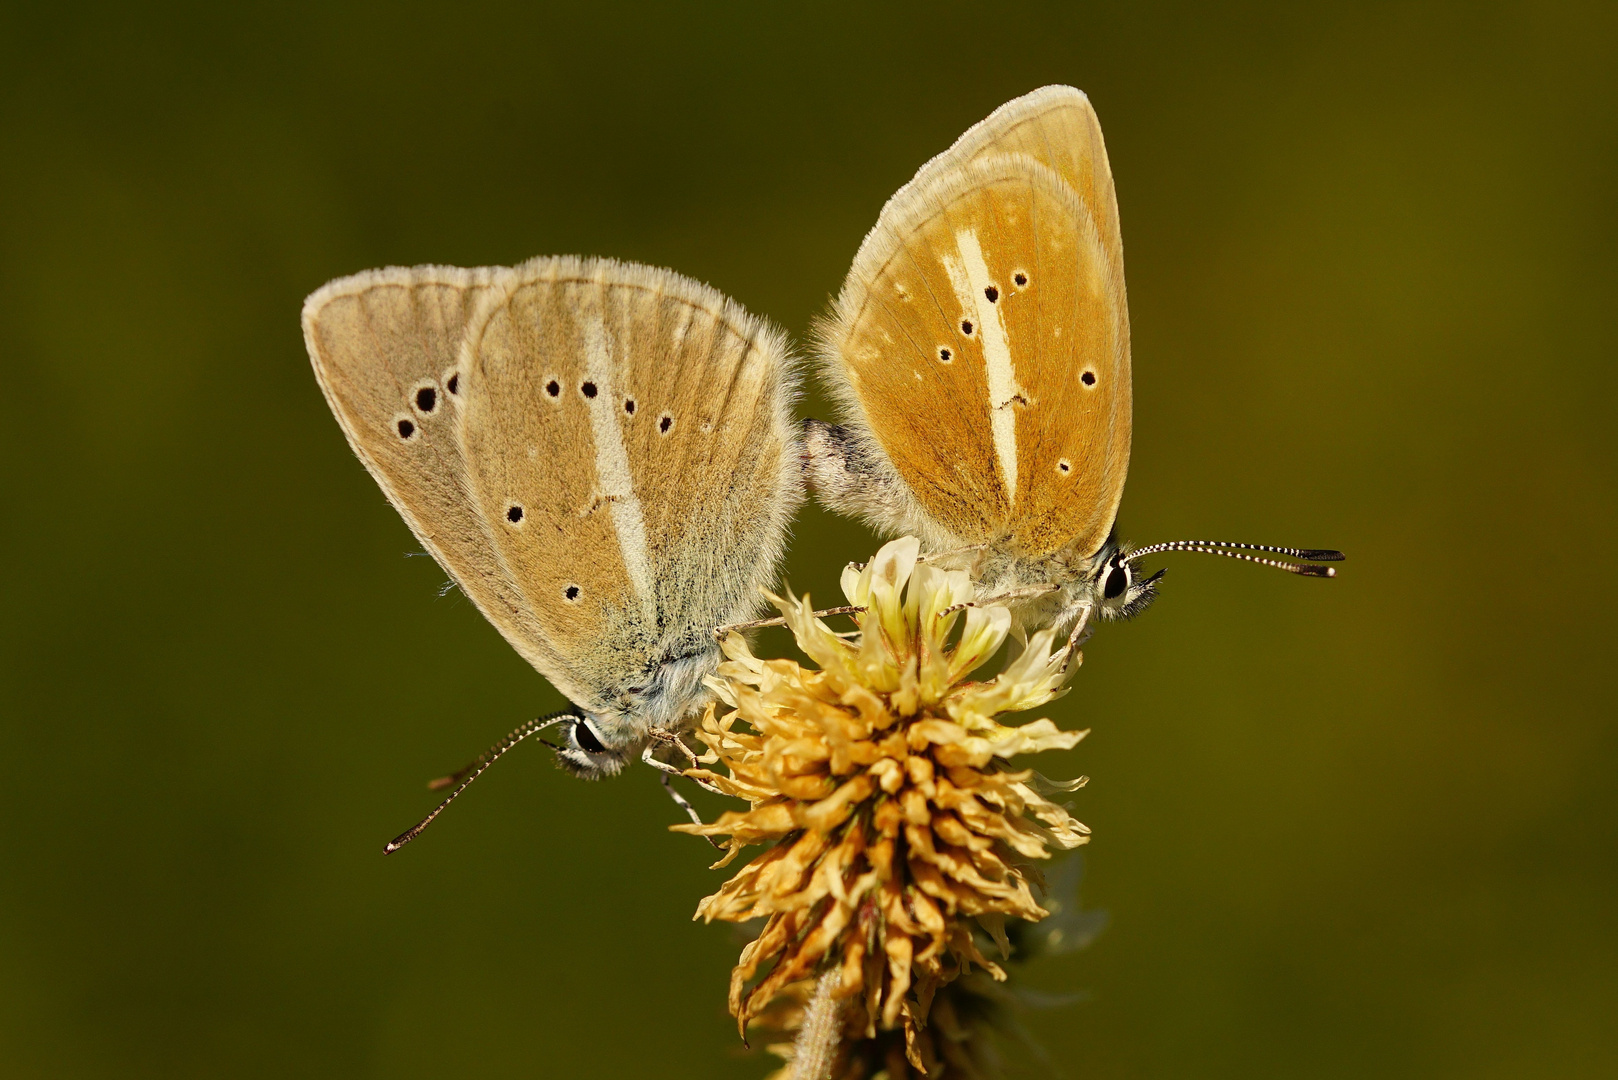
left=676, top=538, right=1089, bottom=1070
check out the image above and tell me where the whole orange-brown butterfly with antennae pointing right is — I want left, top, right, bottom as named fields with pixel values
left=804, top=86, right=1343, bottom=656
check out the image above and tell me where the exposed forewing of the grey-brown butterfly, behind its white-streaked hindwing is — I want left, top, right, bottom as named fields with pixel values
left=303, top=266, right=566, bottom=680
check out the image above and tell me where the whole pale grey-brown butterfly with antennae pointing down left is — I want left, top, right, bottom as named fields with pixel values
left=303, top=257, right=801, bottom=850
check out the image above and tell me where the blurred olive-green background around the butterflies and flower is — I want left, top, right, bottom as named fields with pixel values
left=0, top=3, right=1618, bottom=1080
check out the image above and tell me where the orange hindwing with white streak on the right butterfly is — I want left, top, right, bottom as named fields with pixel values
left=827, top=154, right=1129, bottom=555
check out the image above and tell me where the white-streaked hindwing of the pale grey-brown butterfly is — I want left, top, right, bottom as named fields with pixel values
left=463, top=259, right=796, bottom=693
